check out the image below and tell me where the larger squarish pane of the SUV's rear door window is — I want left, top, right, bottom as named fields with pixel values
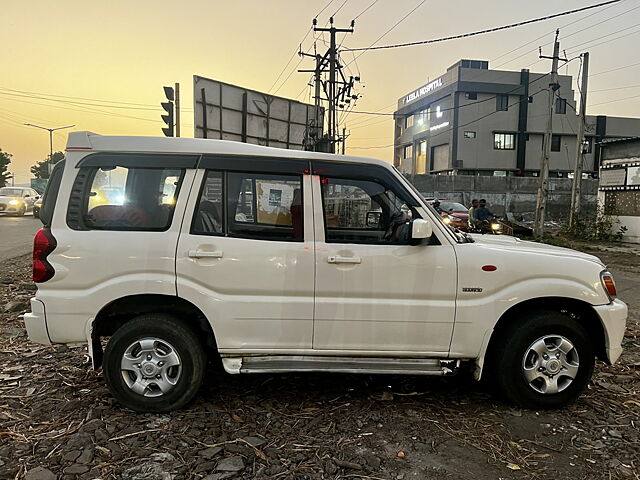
left=226, top=172, right=304, bottom=241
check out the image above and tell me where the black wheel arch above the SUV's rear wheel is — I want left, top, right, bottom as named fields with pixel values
left=88, top=294, right=217, bottom=368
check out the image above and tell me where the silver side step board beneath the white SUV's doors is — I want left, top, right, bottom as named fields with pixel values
left=222, top=355, right=460, bottom=375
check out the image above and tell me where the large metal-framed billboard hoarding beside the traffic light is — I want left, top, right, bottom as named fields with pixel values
left=193, top=75, right=324, bottom=150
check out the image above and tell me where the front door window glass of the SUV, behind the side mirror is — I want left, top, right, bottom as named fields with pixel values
left=322, top=177, right=416, bottom=244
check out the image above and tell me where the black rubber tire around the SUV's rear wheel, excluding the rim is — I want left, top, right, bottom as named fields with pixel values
left=103, top=313, right=206, bottom=412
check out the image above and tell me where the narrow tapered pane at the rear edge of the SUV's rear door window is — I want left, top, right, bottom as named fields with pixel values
left=191, top=171, right=224, bottom=235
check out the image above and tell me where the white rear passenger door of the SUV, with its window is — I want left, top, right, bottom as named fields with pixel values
left=176, top=157, right=314, bottom=353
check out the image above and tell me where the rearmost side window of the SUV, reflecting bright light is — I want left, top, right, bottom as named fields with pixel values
left=82, top=166, right=184, bottom=231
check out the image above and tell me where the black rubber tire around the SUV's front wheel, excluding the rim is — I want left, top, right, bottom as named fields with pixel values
left=487, top=311, right=595, bottom=409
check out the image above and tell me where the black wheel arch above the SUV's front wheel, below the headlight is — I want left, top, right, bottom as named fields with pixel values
left=474, top=297, right=608, bottom=380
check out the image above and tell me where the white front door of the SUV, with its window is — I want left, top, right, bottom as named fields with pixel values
left=313, top=163, right=456, bottom=356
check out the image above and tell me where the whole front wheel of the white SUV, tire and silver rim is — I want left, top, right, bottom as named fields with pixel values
left=490, top=312, right=595, bottom=409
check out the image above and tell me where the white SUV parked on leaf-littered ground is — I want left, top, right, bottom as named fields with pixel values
left=24, top=132, right=627, bottom=411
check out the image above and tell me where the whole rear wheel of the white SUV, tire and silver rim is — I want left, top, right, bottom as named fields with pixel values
left=103, top=314, right=206, bottom=412
